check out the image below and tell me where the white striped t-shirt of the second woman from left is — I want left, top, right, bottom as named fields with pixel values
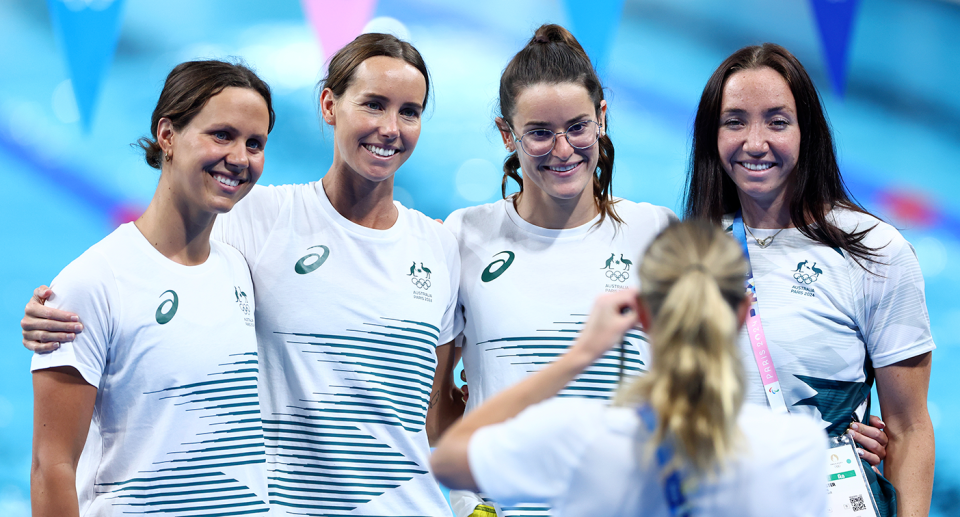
left=214, top=182, right=460, bottom=516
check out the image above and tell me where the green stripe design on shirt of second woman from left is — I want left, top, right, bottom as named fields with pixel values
left=264, top=318, right=440, bottom=515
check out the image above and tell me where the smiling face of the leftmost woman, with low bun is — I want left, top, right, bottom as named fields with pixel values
left=157, top=87, right=270, bottom=214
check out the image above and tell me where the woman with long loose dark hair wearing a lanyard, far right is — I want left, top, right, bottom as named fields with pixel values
left=686, top=43, right=935, bottom=516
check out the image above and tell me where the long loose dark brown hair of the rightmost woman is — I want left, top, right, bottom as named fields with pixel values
left=685, top=43, right=876, bottom=266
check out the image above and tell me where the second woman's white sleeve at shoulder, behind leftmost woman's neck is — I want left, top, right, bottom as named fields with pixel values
left=210, top=185, right=293, bottom=269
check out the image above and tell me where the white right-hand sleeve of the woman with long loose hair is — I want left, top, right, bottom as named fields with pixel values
left=863, top=228, right=936, bottom=368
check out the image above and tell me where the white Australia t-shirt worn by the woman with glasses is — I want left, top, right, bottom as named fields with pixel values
left=444, top=199, right=676, bottom=516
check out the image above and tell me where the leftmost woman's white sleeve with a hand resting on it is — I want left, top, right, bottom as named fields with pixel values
left=30, top=250, right=122, bottom=387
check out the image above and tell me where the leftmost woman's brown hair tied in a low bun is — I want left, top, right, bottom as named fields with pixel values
left=132, top=60, right=277, bottom=169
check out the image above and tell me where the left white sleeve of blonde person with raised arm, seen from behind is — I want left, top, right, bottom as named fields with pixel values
left=467, top=398, right=603, bottom=505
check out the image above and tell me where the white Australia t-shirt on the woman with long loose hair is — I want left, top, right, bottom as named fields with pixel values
left=724, top=209, right=936, bottom=436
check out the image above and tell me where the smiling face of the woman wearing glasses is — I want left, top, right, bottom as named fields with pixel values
left=500, top=83, right=607, bottom=217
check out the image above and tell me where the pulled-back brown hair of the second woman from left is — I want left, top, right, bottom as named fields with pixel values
left=317, top=32, right=430, bottom=108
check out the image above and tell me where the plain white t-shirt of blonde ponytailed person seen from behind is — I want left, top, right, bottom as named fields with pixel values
left=468, top=398, right=827, bottom=517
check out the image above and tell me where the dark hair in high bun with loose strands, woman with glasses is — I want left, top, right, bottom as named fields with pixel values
left=499, top=24, right=623, bottom=224
